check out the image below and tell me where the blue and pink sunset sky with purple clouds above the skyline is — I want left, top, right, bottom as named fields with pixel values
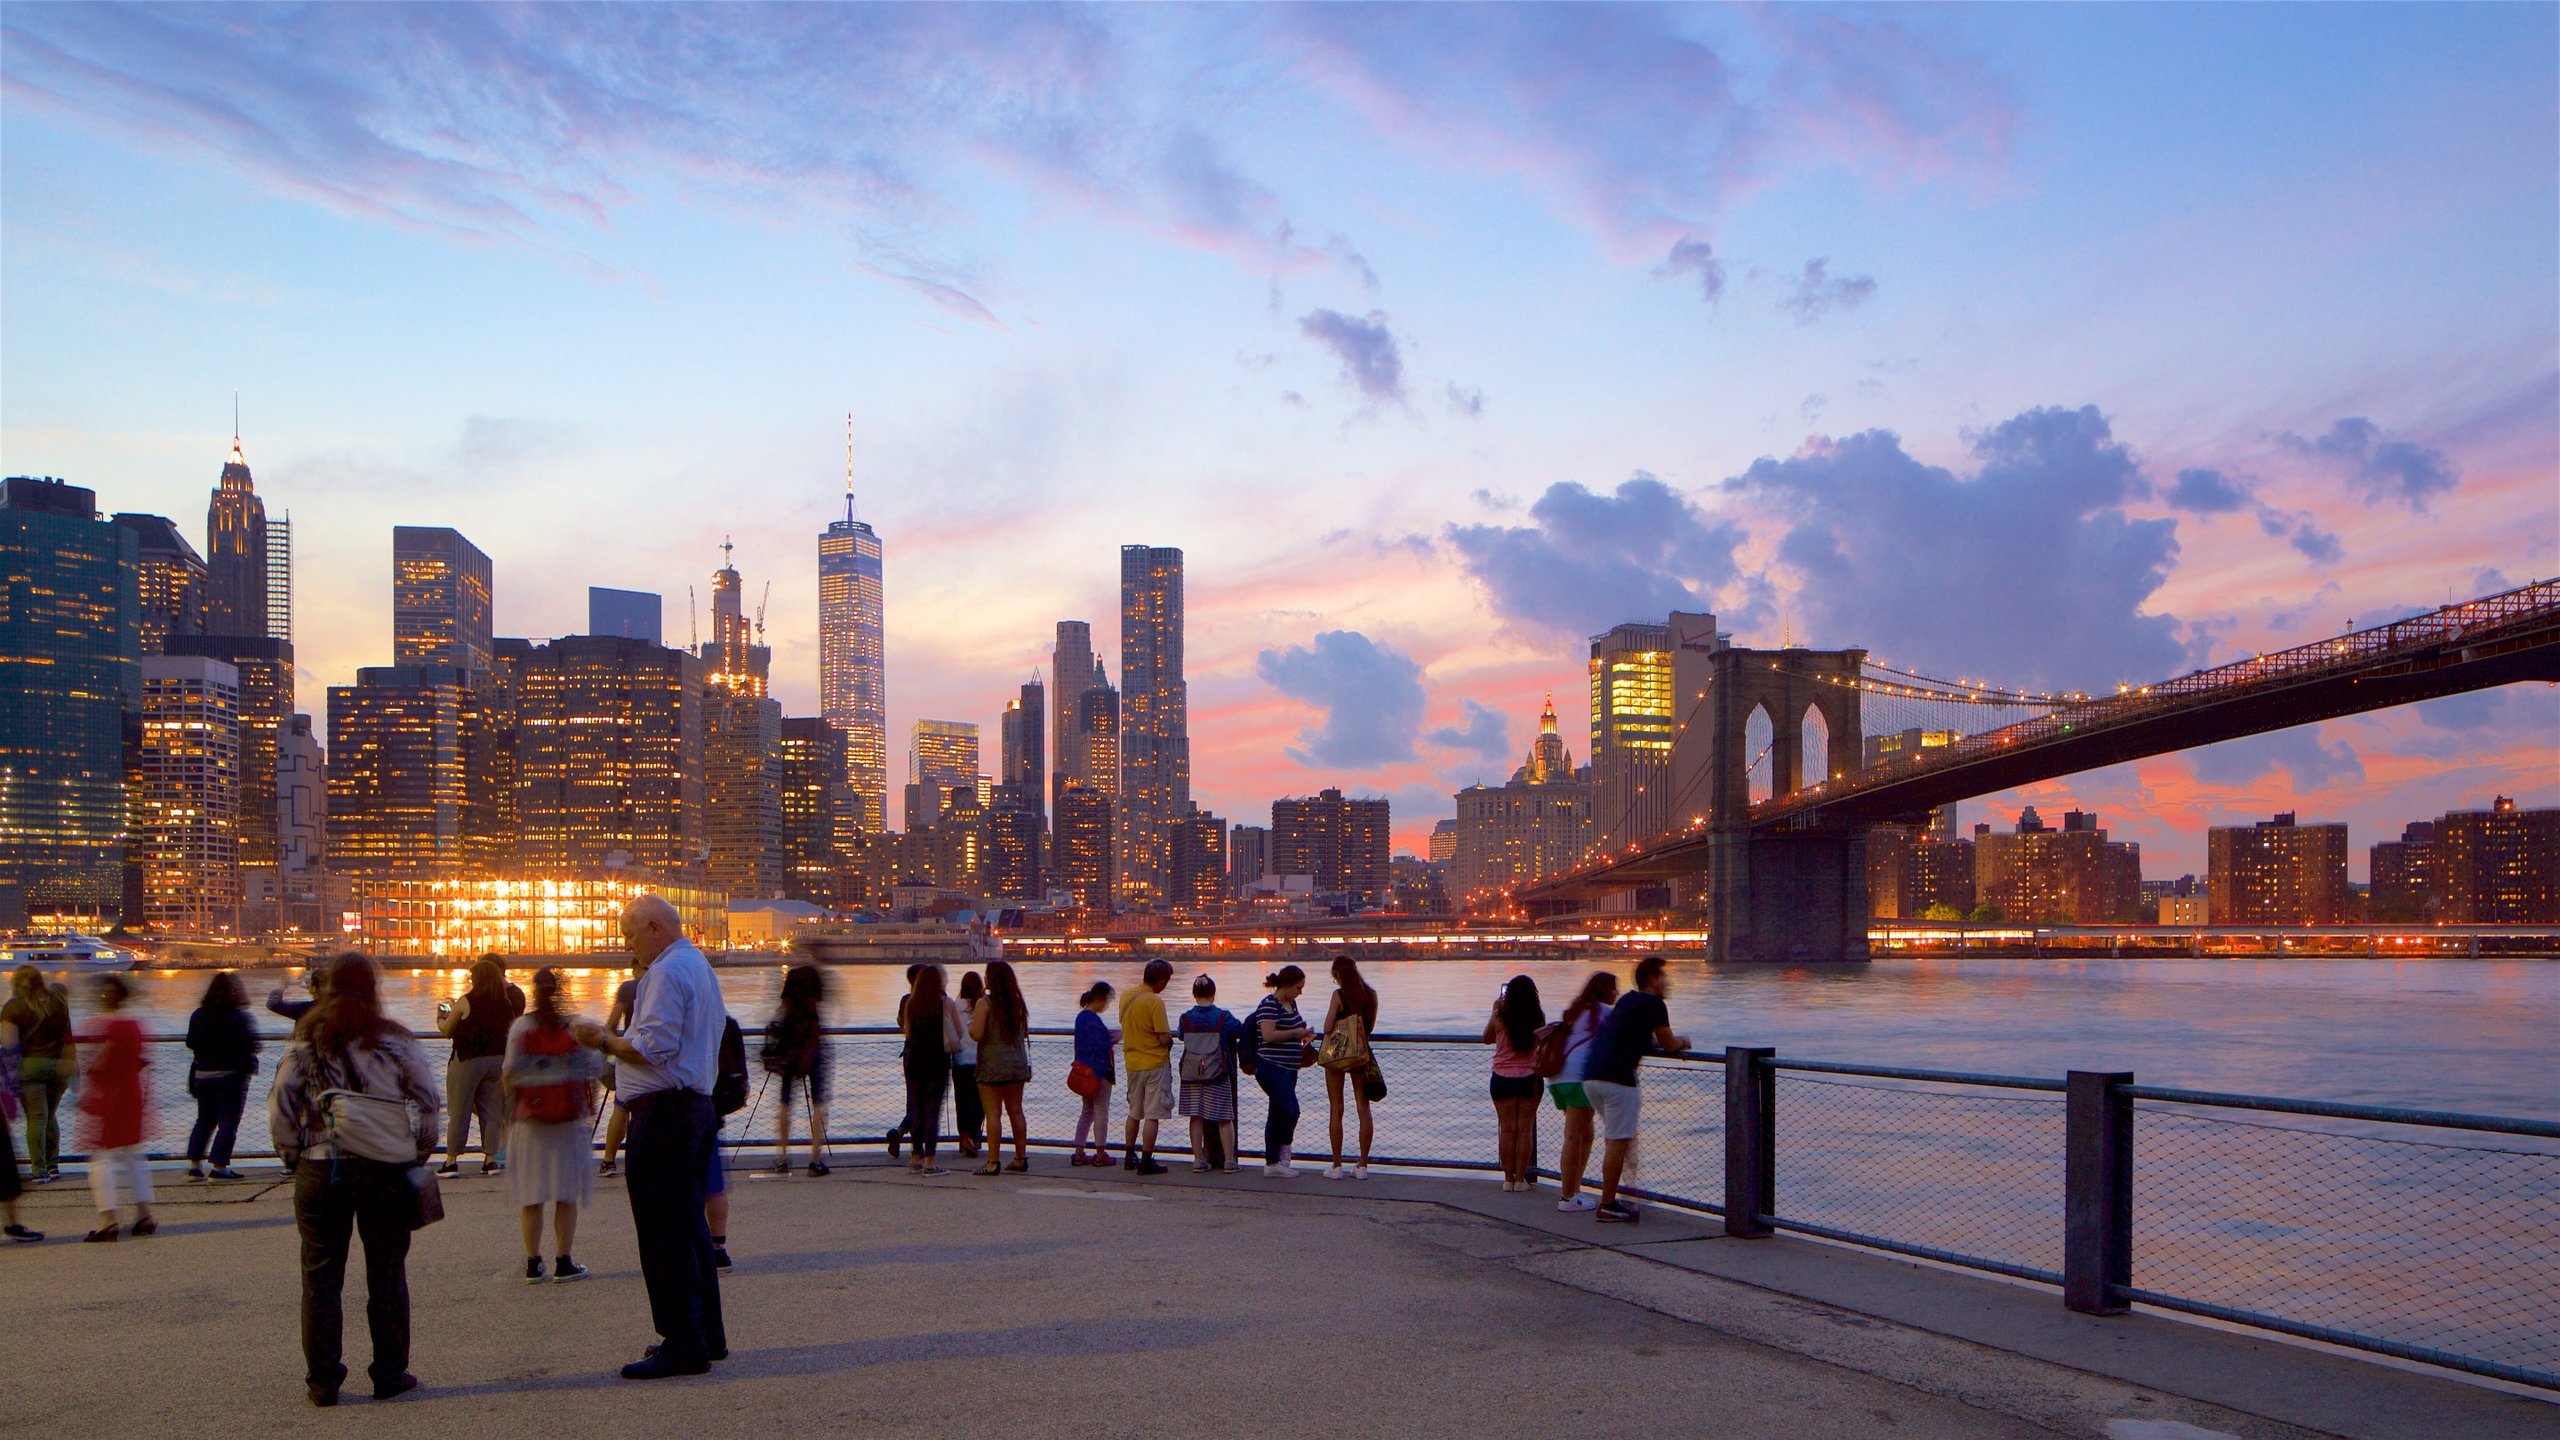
left=0, top=5, right=2560, bottom=879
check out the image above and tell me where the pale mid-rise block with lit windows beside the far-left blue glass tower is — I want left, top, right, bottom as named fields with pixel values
left=133, top=656, right=240, bottom=935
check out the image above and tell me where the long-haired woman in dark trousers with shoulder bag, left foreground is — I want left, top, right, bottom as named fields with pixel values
left=266, top=953, right=443, bottom=1404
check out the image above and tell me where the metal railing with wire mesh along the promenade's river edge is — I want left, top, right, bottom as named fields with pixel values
left=45, top=1027, right=2560, bottom=1389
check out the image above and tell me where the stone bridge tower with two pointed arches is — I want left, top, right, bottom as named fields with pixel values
left=1674, top=646, right=1866, bottom=961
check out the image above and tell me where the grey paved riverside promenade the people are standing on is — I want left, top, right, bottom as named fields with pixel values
left=0, top=1150, right=2560, bottom=1440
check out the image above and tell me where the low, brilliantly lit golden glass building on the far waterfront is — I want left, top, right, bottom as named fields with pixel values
left=361, top=876, right=730, bottom=961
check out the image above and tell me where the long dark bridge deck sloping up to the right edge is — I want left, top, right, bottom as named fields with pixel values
left=1518, top=579, right=2560, bottom=915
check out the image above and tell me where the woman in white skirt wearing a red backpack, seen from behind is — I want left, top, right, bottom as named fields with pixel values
left=502, top=966, right=604, bottom=1284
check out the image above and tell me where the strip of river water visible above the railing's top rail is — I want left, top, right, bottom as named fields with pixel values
left=82, top=956, right=2560, bottom=1117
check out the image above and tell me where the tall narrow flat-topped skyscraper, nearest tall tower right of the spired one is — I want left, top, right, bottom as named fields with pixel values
left=1119, top=546, right=1187, bottom=907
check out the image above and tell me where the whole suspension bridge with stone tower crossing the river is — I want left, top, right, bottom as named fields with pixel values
left=1510, top=579, right=2560, bottom=961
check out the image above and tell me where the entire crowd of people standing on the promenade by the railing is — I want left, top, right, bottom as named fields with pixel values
left=0, top=922, right=1690, bottom=1404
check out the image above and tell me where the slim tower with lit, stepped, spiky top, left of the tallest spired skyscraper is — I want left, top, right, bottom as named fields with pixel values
left=701, top=543, right=783, bottom=899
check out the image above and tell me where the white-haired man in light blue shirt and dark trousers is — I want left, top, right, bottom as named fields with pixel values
left=579, top=894, right=745, bottom=1381
